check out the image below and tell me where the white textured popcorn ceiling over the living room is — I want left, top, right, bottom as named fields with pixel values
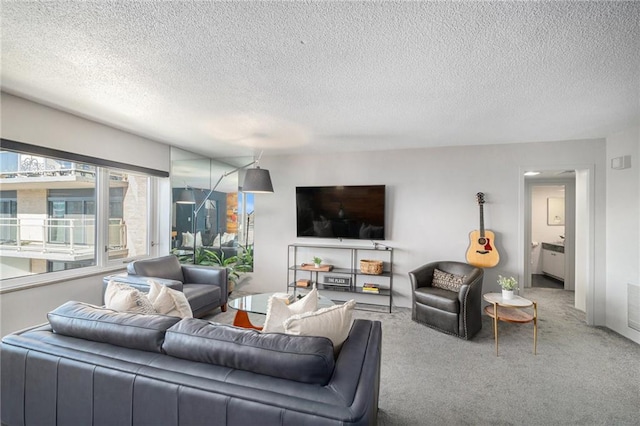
left=1, top=1, right=640, bottom=157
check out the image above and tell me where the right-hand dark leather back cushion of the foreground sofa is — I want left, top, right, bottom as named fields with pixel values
left=162, top=318, right=335, bottom=385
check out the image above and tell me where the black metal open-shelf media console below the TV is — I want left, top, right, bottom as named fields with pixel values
left=287, top=243, right=393, bottom=312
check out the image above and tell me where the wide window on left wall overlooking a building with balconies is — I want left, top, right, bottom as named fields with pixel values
left=0, top=144, right=154, bottom=288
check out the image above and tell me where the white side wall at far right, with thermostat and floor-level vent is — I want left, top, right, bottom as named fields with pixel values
left=606, top=128, right=640, bottom=342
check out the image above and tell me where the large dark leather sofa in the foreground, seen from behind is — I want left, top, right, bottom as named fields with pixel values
left=0, top=302, right=382, bottom=426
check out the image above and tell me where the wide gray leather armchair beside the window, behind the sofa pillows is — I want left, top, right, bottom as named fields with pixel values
left=107, top=255, right=229, bottom=317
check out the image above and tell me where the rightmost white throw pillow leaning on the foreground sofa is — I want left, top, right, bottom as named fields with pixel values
left=284, top=299, right=356, bottom=354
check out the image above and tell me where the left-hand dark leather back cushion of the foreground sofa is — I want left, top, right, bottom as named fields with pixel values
left=47, top=301, right=180, bottom=353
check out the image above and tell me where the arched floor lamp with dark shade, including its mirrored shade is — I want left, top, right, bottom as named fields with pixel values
left=176, top=153, right=273, bottom=265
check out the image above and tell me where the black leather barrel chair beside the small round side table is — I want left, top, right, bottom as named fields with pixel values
left=409, top=261, right=484, bottom=339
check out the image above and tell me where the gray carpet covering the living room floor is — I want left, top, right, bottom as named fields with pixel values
left=208, top=288, right=640, bottom=426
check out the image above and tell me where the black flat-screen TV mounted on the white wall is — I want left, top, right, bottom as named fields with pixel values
left=296, top=185, right=385, bottom=240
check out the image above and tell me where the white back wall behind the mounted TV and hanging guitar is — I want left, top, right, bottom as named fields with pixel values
left=250, top=140, right=605, bottom=321
